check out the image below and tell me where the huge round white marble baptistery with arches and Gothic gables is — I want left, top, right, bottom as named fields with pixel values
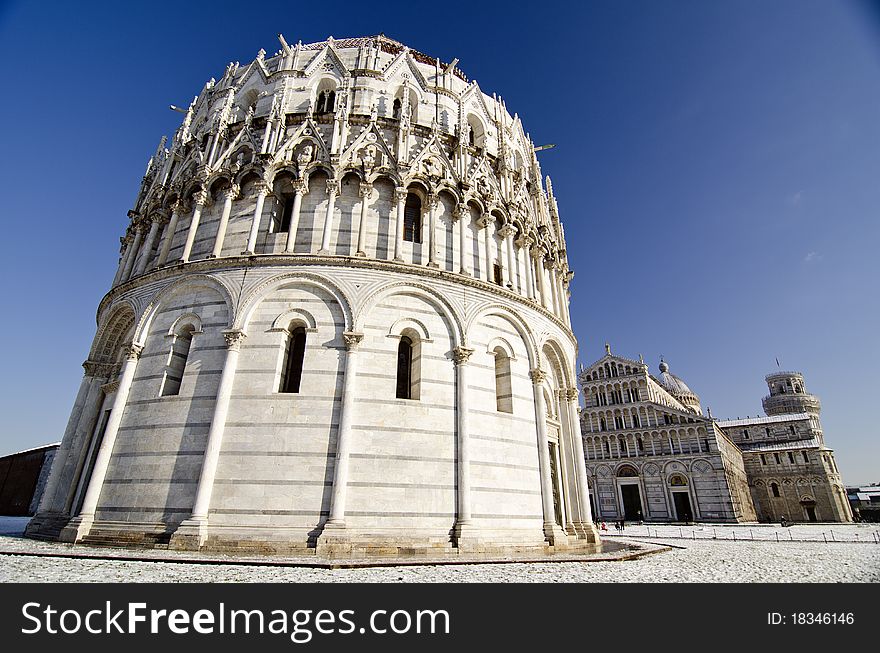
left=27, top=35, right=597, bottom=556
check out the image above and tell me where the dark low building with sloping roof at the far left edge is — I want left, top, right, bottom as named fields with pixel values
left=0, top=442, right=59, bottom=517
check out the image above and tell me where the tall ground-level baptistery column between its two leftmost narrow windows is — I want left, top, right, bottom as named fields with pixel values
left=171, top=329, right=247, bottom=549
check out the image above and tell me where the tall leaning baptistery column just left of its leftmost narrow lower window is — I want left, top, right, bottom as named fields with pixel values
left=59, top=343, right=143, bottom=542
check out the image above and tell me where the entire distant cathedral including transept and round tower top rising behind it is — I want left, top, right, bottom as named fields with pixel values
left=579, top=345, right=852, bottom=522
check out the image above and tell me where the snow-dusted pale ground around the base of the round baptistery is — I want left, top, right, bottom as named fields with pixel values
left=0, top=518, right=880, bottom=583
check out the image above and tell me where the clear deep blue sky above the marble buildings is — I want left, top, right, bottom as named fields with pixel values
left=0, top=0, right=880, bottom=484
